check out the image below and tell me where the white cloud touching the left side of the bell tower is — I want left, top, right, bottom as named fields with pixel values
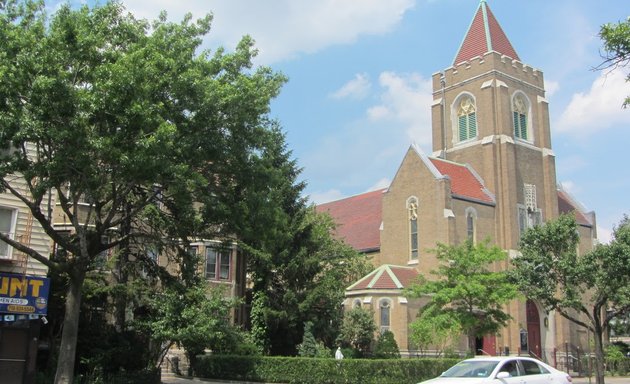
left=368, top=72, right=433, bottom=146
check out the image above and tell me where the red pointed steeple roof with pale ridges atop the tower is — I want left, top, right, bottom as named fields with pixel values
left=453, top=0, right=520, bottom=65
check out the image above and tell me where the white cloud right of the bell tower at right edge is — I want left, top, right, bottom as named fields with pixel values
left=554, top=70, right=630, bottom=136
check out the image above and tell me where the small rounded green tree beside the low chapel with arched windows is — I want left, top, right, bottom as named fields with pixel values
left=338, top=307, right=376, bottom=356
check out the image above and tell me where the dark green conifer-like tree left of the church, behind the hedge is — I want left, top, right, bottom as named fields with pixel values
left=243, top=202, right=367, bottom=355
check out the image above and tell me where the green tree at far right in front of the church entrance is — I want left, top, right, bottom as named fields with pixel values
left=512, top=215, right=630, bottom=384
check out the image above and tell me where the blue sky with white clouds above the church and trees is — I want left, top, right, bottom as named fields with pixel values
left=49, top=0, right=630, bottom=241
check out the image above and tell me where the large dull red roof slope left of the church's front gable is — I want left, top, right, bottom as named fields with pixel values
left=317, top=189, right=385, bottom=251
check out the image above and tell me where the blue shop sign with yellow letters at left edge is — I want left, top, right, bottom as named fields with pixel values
left=0, top=273, right=50, bottom=315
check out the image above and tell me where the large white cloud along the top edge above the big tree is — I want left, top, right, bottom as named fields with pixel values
left=124, top=0, right=416, bottom=64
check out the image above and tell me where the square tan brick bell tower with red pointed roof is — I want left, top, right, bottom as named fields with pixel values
left=432, top=0, right=558, bottom=250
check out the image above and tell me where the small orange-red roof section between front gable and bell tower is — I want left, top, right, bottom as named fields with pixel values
left=429, top=158, right=495, bottom=204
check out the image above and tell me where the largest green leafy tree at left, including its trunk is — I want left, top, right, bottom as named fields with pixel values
left=0, top=0, right=285, bottom=383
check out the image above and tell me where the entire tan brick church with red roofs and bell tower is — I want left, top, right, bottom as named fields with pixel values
left=317, top=0, right=597, bottom=361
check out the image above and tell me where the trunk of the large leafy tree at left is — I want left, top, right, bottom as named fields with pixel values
left=55, top=271, right=85, bottom=384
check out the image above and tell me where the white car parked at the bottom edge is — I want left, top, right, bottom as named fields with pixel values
left=420, top=356, right=572, bottom=384
